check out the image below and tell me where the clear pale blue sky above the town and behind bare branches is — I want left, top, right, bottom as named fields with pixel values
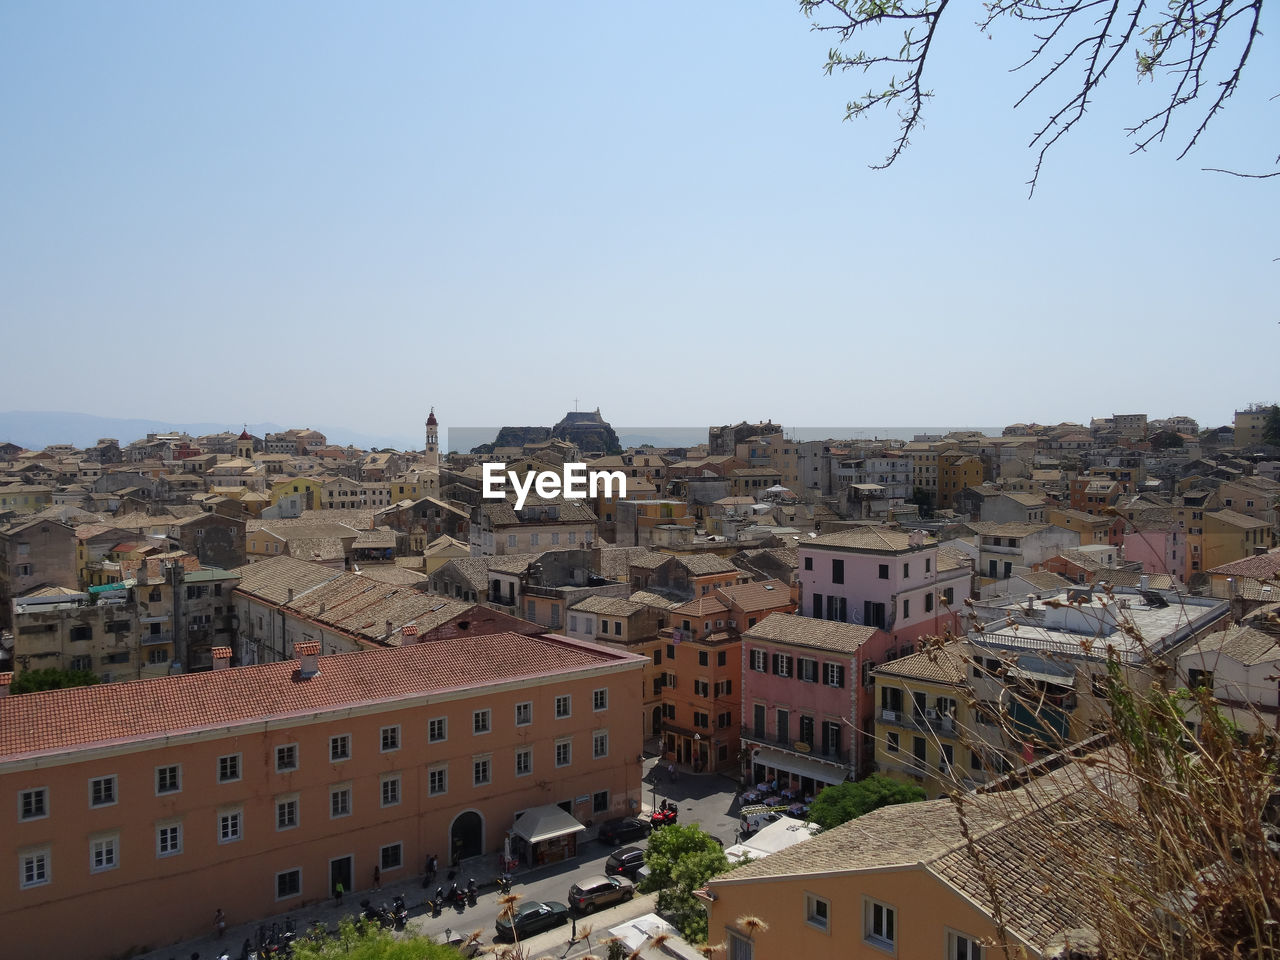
left=0, top=0, right=1280, bottom=450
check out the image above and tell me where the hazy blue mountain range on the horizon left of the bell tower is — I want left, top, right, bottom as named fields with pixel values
left=0, top=410, right=404, bottom=451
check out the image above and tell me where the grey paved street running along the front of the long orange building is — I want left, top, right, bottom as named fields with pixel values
left=140, top=759, right=739, bottom=960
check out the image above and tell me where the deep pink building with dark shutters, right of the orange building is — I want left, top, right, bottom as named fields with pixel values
left=741, top=613, right=892, bottom=794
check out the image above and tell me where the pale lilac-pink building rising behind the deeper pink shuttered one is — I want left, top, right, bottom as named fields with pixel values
left=796, top=526, right=972, bottom=653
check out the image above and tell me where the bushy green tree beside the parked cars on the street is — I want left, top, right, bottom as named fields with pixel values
left=640, top=823, right=728, bottom=943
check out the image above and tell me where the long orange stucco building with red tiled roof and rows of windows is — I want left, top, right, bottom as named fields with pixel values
left=0, top=634, right=646, bottom=960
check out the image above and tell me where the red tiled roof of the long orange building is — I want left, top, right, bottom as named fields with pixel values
left=0, top=634, right=644, bottom=760
